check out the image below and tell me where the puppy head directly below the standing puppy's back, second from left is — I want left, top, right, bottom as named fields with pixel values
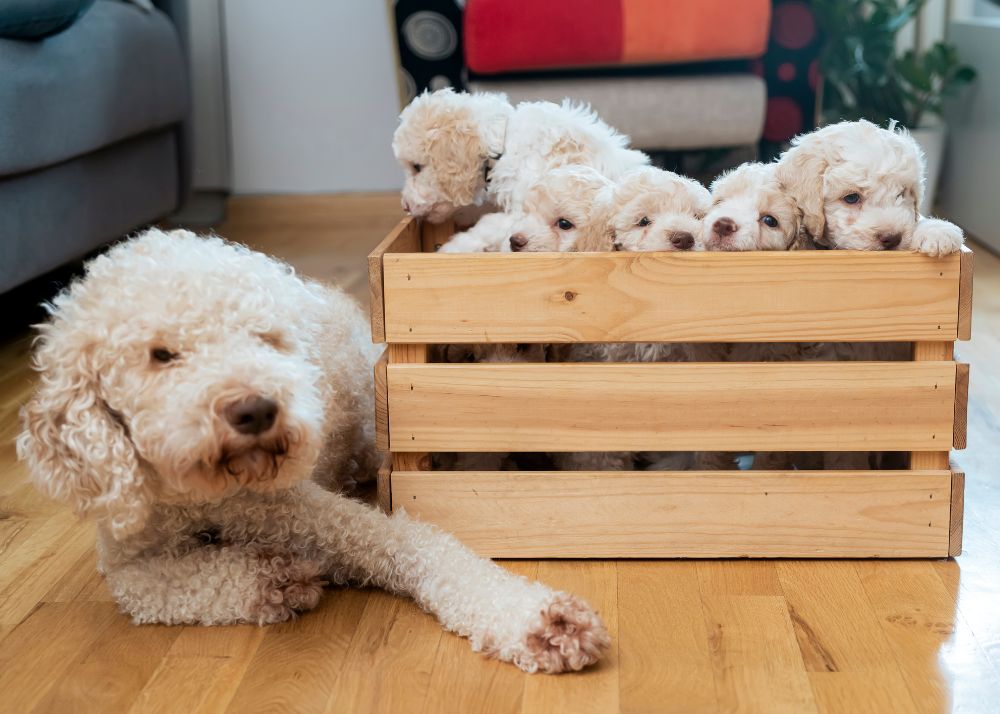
left=504, top=166, right=611, bottom=252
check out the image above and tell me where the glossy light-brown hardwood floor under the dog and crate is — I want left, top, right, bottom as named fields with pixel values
left=0, top=195, right=1000, bottom=713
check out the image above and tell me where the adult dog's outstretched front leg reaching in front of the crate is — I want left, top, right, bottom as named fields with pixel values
left=287, top=486, right=610, bottom=672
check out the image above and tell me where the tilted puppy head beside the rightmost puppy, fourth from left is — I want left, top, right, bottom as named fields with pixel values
left=703, top=163, right=802, bottom=251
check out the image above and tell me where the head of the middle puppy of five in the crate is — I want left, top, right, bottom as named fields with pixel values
left=609, top=166, right=711, bottom=251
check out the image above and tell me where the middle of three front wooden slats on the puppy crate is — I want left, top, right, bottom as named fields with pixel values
left=388, top=362, right=955, bottom=450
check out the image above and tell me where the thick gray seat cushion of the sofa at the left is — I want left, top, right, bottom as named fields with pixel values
left=0, top=0, right=188, bottom=176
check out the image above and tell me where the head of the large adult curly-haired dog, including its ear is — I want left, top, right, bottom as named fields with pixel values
left=17, top=230, right=336, bottom=537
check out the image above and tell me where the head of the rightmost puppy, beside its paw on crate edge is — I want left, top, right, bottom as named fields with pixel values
left=776, top=120, right=924, bottom=250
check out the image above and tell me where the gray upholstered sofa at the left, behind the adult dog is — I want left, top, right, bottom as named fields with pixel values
left=0, top=0, right=190, bottom=293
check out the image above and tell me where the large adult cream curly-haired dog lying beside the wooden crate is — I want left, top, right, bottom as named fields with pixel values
left=17, top=230, right=609, bottom=672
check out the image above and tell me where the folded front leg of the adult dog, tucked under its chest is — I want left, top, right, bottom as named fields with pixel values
left=106, top=546, right=327, bottom=625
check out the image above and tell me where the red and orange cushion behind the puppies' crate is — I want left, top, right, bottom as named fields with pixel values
left=463, top=0, right=771, bottom=74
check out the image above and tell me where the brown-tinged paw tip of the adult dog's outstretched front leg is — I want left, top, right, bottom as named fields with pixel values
left=515, top=593, right=611, bottom=674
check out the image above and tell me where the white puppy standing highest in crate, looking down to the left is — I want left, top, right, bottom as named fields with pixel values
left=392, top=89, right=649, bottom=223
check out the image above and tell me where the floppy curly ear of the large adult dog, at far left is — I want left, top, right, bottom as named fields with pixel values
left=17, top=324, right=151, bottom=539
